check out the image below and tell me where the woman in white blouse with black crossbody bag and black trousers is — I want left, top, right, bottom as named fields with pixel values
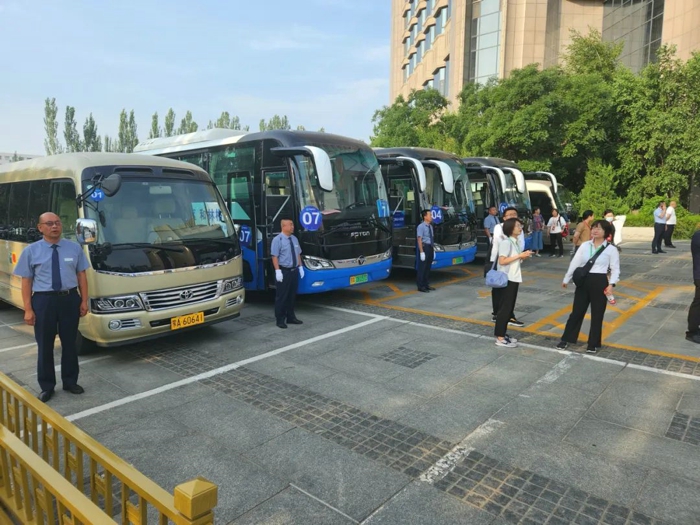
left=557, top=221, right=620, bottom=354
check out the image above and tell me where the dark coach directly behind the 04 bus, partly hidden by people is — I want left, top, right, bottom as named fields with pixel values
left=462, top=157, right=532, bottom=253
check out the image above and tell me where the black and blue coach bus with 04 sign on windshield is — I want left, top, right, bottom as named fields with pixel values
left=375, top=148, right=477, bottom=268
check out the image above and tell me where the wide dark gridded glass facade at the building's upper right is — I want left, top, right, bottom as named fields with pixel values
left=603, top=0, right=665, bottom=72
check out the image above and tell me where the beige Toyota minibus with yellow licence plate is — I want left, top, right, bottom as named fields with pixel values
left=0, top=153, right=245, bottom=353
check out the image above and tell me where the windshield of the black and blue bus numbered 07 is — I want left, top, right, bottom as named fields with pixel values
left=295, top=144, right=389, bottom=223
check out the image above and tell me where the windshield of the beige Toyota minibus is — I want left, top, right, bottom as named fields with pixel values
left=84, top=176, right=240, bottom=272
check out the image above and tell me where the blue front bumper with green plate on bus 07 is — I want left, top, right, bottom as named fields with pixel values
left=297, top=258, right=391, bottom=294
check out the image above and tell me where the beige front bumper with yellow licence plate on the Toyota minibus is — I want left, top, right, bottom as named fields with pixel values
left=79, top=288, right=245, bottom=347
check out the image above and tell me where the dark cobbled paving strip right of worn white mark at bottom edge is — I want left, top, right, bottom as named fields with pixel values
left=435, top=451, right=661, bottom=525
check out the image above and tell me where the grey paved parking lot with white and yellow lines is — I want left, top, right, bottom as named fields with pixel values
left=0, top=239, right=700, bottom=525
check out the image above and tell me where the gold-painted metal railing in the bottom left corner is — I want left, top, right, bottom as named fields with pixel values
left=0, top=373, right=217, bottom=525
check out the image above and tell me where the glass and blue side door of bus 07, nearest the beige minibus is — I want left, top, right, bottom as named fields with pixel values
left=225, top=171, right=262, bottom=290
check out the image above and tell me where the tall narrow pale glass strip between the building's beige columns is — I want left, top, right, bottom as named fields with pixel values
left=469, top=0, right=501, bottom=84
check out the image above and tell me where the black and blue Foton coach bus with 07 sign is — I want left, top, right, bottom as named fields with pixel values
left=135, top=129, right=391, bottom=294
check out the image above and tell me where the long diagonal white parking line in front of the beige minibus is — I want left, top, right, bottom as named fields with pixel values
left=66, top=316, right=387, bottom=421
